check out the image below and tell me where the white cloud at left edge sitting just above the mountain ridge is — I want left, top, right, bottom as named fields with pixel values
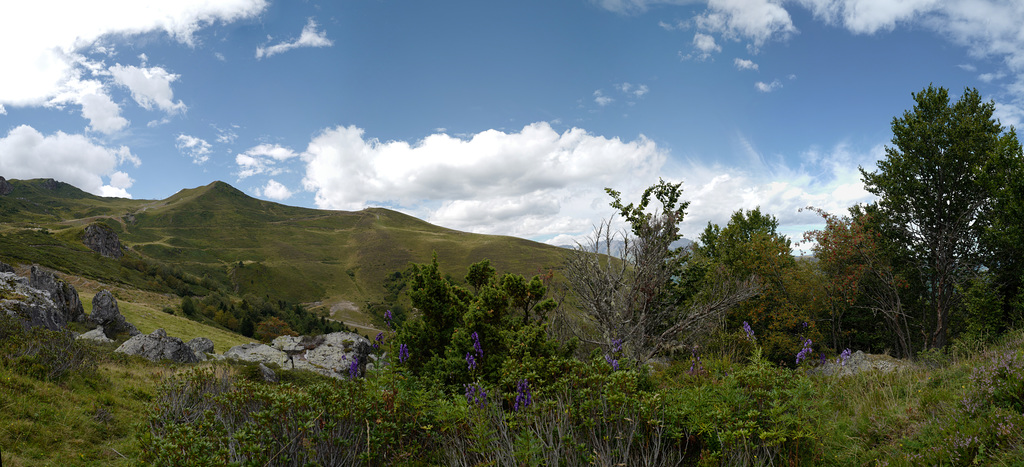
left=0, top=125, right=140, bottom=198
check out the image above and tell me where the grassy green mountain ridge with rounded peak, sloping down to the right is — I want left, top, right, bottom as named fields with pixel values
left=0, top=179, right=565, bottom=325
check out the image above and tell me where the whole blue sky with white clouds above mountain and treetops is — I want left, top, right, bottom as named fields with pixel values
left=0, top=0, right=1024, bottom=244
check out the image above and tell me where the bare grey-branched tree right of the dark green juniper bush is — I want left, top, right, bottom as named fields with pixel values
left=565, top=216, right=760, bottom=363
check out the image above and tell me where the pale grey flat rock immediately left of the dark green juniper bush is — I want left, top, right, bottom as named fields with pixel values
left=224, top=333, right=372, bottom=378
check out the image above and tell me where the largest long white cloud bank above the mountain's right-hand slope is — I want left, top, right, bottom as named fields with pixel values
left=301, top=122, right=667, bottom=238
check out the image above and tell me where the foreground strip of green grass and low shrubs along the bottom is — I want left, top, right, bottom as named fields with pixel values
left=0, top=305, right=1024, bottom=466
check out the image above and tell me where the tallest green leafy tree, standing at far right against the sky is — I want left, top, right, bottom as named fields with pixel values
left=860, top=86, right=1020, bottom=347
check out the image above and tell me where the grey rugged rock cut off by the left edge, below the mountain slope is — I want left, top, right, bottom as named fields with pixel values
left=0, top=271, right=68, bottom=331
